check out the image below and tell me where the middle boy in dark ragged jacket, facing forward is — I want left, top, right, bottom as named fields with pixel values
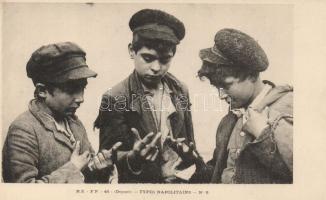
left=95, top=9, right=201, bottom=183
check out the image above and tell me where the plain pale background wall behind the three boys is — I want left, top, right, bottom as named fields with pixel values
left=1, top=3, right=294, bottom=160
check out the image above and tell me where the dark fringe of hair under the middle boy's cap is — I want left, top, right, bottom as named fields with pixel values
left=131, top=33, right=177, bottom=55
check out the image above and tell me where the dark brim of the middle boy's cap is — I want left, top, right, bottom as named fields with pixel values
left=137, top=29, right=180, bottom=44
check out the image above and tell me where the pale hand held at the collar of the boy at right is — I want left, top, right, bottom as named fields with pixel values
left=242, top=107, right=268, bottom=138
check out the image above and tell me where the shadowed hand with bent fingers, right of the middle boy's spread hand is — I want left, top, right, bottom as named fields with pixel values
left=165, top=136, right=198, bottom=166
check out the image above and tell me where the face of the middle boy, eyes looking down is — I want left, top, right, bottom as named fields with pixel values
left=129, top=47, right=174, bottom=87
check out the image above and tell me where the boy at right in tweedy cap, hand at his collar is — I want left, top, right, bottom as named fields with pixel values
left=188, top=29, right=293, bottom=183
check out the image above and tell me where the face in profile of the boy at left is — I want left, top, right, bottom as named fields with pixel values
left=45, top=79, right=87, bottom=117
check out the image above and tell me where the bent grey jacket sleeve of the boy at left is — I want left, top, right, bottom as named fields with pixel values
left=3, top=126, right=84, bottom=183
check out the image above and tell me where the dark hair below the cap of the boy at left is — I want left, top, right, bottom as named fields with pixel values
left=33, top=78, right=87, bottom=98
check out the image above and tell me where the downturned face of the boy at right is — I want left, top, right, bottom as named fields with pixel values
left=211, top=76, right=255, bottom=109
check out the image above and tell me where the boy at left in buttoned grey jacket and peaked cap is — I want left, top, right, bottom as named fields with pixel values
left=2, top=42, right=120, bottom=183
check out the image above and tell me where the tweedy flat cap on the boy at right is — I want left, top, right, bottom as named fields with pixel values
left=199, top=29, right=269, bottom=72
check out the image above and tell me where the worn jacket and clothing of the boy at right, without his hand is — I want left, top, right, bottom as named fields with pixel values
left=192, top=81, right=293, bottom=183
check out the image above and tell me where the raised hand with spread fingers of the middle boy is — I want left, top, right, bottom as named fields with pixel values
left=127, top=128, right=161, bottom=169
